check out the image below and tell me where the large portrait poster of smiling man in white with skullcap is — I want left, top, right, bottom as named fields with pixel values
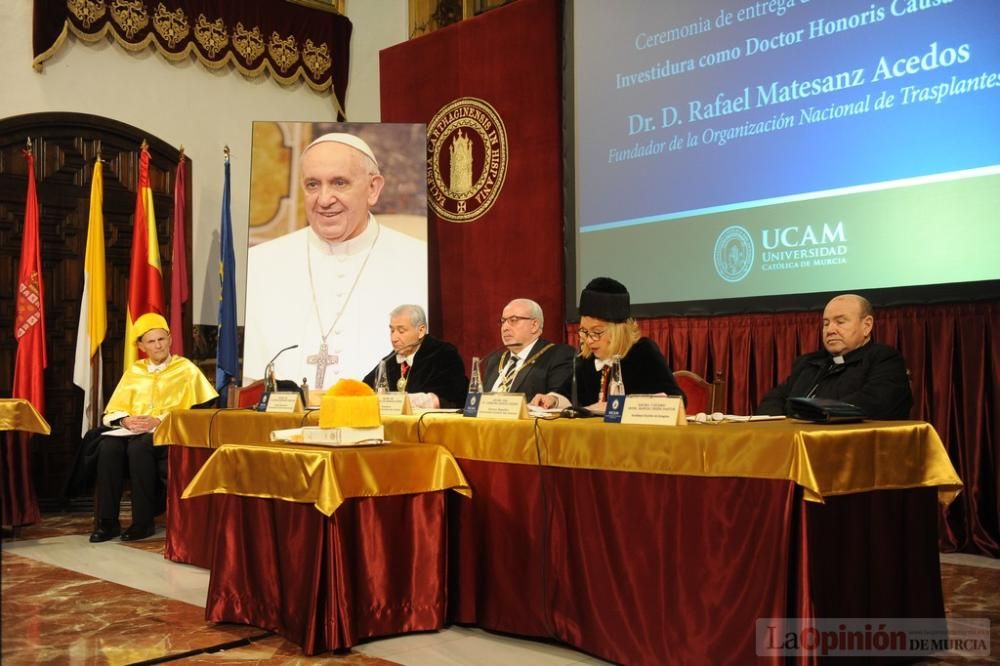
left=243, top=122, right=427, bottom=390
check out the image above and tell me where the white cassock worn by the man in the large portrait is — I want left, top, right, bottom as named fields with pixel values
left=243, top=216, right=427, bottom=389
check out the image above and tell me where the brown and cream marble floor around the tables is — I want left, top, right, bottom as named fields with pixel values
left=0, top=514, right=1000, bottom=666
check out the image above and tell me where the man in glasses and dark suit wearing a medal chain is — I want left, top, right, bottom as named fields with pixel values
left=483, top=298, right=574, bottom=400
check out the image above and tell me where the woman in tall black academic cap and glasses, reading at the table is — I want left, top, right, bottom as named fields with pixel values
left=533, top=277, right=686, bottom=410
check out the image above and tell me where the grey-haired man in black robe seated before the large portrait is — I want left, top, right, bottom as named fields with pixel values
left=364, top=305, right=469, bottom=409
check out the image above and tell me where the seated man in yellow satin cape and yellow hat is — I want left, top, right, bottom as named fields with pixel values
left=80, top=313, right=218, bottom=543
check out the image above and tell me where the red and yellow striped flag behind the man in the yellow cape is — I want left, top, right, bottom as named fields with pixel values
left=124, top=142, right=166, bottom=371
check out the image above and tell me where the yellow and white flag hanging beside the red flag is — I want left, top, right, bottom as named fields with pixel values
left=73, top=158, right=108, bottom=434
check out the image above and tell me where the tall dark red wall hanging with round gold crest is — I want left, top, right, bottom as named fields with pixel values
left=380, top=0, right=564, bottom=359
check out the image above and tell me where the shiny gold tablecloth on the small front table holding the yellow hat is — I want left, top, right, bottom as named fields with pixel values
left=182, top=443, right=472, bottom=516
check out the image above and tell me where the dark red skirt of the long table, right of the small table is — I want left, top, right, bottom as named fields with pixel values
left=449, top=460, right=944, bottom=664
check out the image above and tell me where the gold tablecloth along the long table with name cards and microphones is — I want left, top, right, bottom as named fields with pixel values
left=155, top=410, right=962, bottom=504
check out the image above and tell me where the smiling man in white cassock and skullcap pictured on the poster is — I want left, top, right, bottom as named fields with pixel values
left=243, top=134, right=427, bottom=389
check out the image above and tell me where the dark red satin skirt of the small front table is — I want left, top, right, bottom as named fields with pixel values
left=205, top=491, right=447, bottom=655
